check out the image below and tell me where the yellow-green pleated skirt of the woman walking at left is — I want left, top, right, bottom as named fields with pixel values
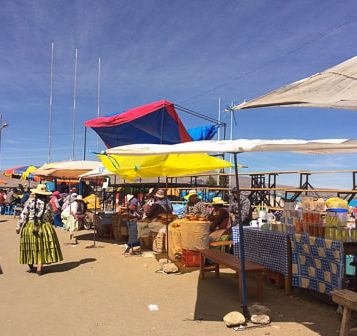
left=19, top=220, right=63, bottom=265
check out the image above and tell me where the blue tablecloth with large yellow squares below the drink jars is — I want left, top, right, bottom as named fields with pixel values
left=290, top=233, right=345, bottom=294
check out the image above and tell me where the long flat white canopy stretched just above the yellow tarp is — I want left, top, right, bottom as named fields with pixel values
left=106, top=139, right=357, bottom=155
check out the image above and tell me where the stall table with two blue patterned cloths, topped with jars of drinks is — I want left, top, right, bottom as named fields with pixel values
left=233, top=198, right=357, bottom=294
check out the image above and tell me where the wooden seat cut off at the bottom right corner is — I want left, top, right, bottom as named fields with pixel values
left=332, top=289, right=357, bottom=336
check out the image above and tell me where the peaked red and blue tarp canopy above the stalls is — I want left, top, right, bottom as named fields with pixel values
left=84, top=100, right=193, bottom=148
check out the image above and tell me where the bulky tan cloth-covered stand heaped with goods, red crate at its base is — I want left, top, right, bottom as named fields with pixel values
left=168, top=216, right=211, bottom=267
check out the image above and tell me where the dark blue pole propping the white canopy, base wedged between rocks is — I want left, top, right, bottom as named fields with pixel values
left=234, top=153, right=249, bottom=317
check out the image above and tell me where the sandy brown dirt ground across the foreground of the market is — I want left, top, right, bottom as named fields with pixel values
left=0, top=216, right=356, bottom=336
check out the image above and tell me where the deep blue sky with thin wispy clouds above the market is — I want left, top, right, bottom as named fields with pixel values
left=0, top=0, right=357, bottom=187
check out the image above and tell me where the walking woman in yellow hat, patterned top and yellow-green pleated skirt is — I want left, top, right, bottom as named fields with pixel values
left=16, top=184, right=63, bottom=275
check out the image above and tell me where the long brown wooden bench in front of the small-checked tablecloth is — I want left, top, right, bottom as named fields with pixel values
left=199, top=249, right=265, bottom=300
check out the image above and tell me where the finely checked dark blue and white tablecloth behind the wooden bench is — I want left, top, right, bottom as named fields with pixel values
left=232, top=227, right=290, bottom=276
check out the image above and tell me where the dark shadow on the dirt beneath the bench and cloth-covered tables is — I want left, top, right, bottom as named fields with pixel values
left=194, top=270, right=346, bottom=336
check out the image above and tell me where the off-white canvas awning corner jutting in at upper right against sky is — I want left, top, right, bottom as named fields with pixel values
left=233, top=56, right=357, bottom=110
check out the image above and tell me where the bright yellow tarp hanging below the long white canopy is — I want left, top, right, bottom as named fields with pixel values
left=98, top=153, right=231, bottom=180
